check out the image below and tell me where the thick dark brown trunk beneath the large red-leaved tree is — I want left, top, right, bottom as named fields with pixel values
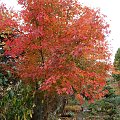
left=31, top=91, right=66, bottom=120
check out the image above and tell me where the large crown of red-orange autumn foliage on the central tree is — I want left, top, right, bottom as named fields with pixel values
left=2, top=0, right=110, bottom=120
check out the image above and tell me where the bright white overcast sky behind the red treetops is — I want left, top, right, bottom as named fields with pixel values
left=0, top=0, right=120, bottom=61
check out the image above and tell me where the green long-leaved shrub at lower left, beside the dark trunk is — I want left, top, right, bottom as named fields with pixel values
left=0, top=82, right=34, bottom=120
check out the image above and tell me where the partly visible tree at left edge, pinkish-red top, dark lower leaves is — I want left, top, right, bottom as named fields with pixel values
left=0, top=4, right=17, bottom=98
